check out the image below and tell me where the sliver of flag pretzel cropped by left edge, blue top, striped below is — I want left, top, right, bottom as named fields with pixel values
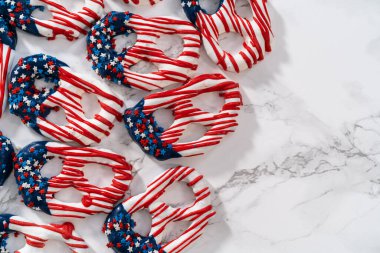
left=0, top=13, right=17, bottom=118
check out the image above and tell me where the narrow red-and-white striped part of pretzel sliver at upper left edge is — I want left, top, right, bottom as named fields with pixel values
left=0, top=43, right=14, bottom=118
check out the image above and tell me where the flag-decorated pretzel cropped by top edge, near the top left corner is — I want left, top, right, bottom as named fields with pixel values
left=11, top=0, right=104, bottom=40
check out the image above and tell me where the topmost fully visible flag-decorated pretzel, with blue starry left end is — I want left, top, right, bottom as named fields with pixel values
left=87, top=12, right=201, bottom=91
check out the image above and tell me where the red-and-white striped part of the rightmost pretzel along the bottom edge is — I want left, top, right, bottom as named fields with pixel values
left=123, top=167, right=215, bottom=253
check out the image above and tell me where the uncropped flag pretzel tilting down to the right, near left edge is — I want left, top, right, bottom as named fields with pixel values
left=9, top=54, right=123, bottom=145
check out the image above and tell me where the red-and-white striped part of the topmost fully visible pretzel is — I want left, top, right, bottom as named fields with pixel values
left=123, top=14, right=201, bottom=90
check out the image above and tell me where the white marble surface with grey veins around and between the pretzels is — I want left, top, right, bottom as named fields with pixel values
left=0, top=0, right=380, bottom=253
